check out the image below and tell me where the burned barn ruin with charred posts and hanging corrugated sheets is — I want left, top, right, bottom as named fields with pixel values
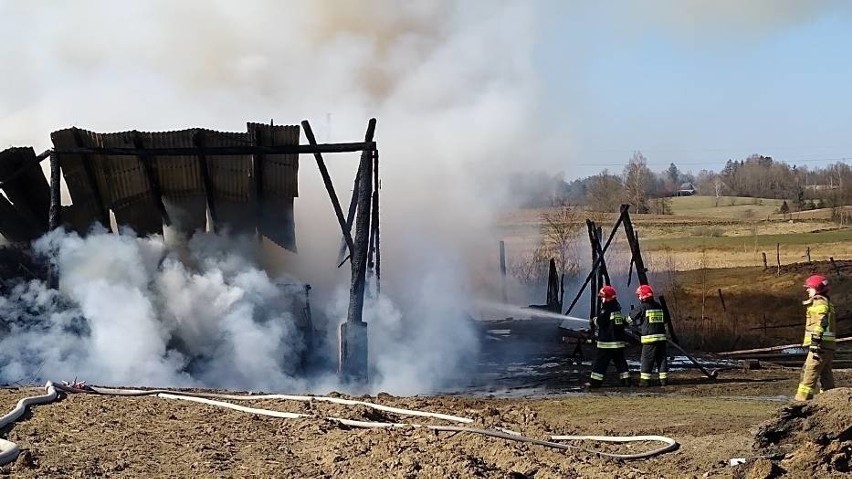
left=0, top=119, right=381, bottom=381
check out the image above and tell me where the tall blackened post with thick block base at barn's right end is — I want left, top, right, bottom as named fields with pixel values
left=338, top=118, right=376, bottom=384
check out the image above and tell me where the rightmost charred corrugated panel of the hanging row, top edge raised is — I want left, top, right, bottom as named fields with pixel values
left=248, top=123, right=300, bottom=251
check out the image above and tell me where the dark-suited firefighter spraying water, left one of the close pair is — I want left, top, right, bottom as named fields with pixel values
left=587, top=285, right=630, bottom=388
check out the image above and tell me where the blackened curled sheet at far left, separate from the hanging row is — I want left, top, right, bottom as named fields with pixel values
left=0, top=147, right=50, bottom=239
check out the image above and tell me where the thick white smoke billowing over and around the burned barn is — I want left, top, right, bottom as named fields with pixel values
left=0, top=0, right=537, bottom=393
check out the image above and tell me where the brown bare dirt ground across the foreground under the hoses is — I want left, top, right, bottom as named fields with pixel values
left=0, top=368, right=852, bottom=478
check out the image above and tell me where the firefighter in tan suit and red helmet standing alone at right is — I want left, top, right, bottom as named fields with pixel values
left=796, top=274, right=837, bottom=401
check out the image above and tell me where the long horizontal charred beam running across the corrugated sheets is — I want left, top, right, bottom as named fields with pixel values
left=52, top=142, right=376, bottom=156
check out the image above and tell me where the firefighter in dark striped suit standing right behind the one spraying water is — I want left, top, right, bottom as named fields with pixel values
left=630, top=284, right=669, bottom=386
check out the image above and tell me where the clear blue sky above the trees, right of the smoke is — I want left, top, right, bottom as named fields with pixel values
left=534, top=1, right=852, bottom=177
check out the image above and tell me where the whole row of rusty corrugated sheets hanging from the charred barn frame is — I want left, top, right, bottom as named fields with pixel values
left=51, top=123, right=300, bottom=251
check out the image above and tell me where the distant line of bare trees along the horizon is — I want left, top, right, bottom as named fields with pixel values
left=511, top=151, right=852, bottom=218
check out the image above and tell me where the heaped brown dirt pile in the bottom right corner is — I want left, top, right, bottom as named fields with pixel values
left=742, top=388, right=852, bottom=477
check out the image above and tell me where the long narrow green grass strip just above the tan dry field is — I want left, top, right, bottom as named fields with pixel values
left=642, top=229, right=852, bottom=250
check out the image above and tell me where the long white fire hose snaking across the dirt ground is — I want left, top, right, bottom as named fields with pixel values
left=0, top=381, right=680, bottom=466
